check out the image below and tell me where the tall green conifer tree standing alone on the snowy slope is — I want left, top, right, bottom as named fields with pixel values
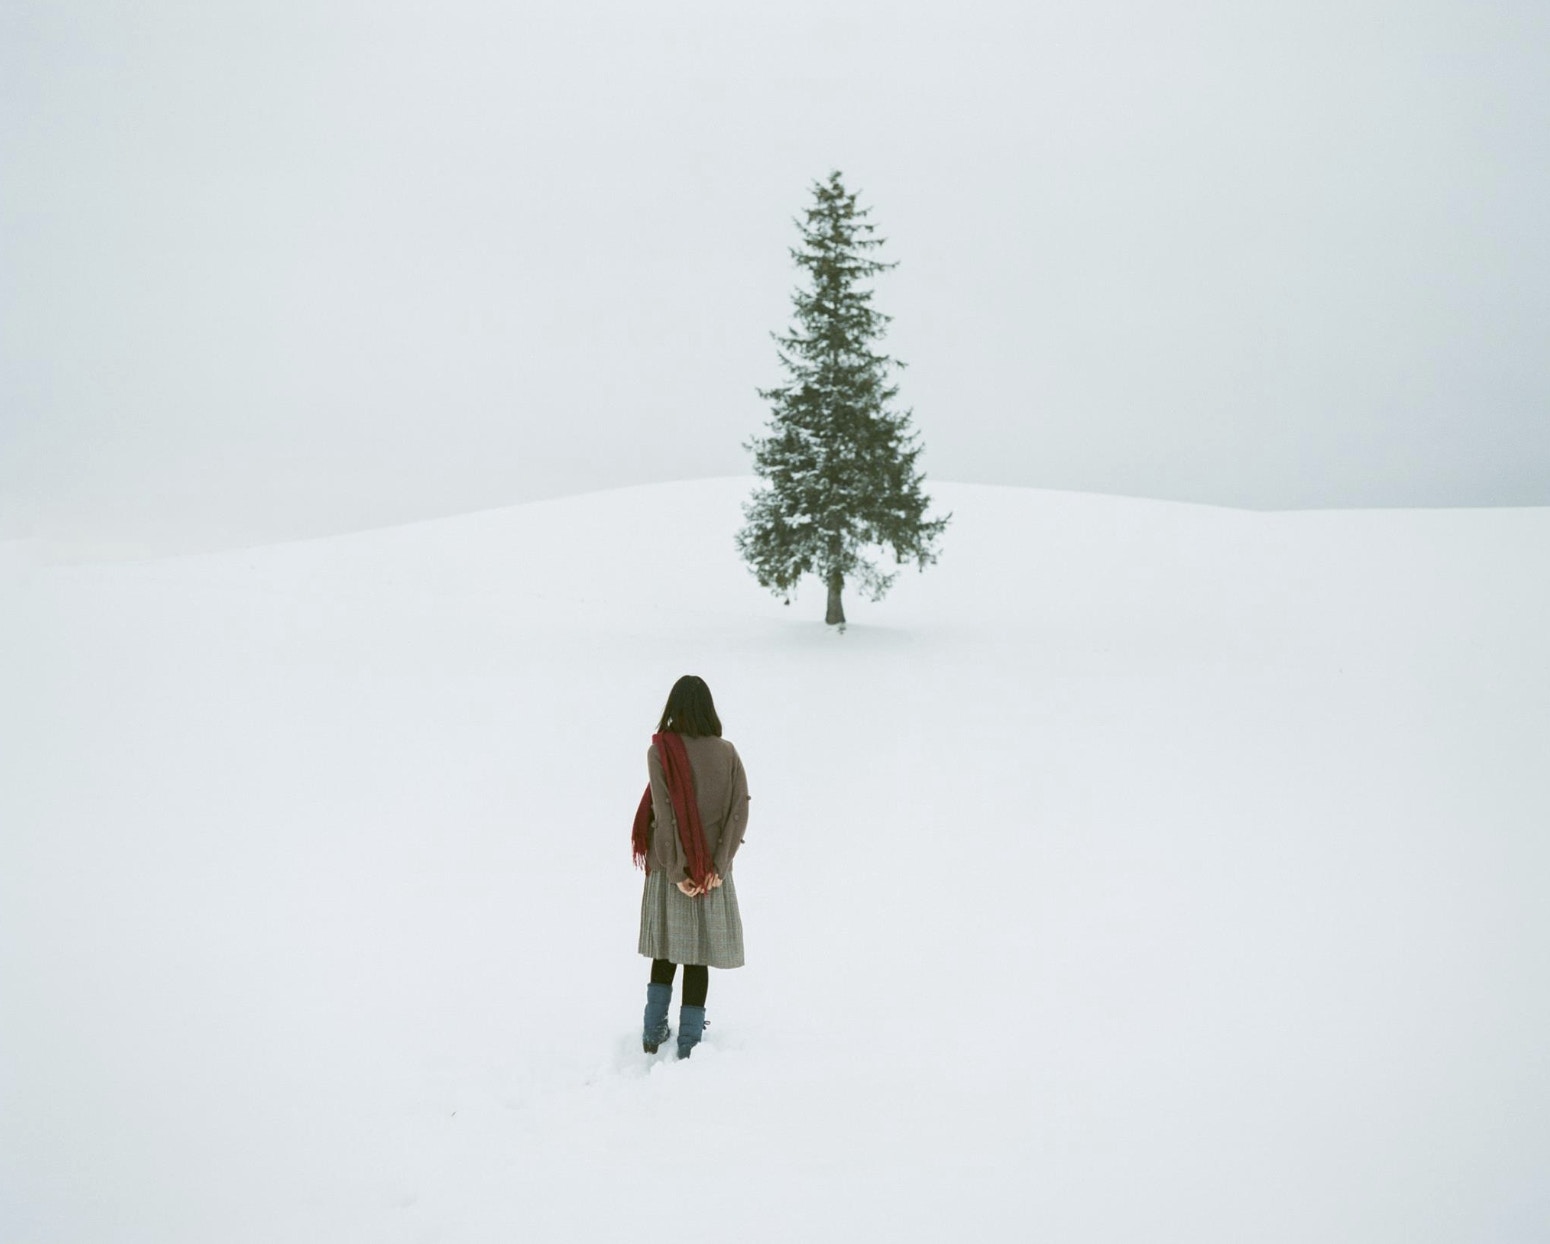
left=738, top=172, right=952, bottom=627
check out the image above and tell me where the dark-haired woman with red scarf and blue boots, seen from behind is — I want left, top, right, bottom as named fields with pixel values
left=632, top=674, right=749, bottom=1058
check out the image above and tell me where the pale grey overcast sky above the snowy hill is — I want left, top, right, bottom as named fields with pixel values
left=0, top=0, right=1550, bottom=541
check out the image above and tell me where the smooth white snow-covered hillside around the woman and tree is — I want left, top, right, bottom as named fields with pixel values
left=0, top=480, right=1550, bottom=1244
